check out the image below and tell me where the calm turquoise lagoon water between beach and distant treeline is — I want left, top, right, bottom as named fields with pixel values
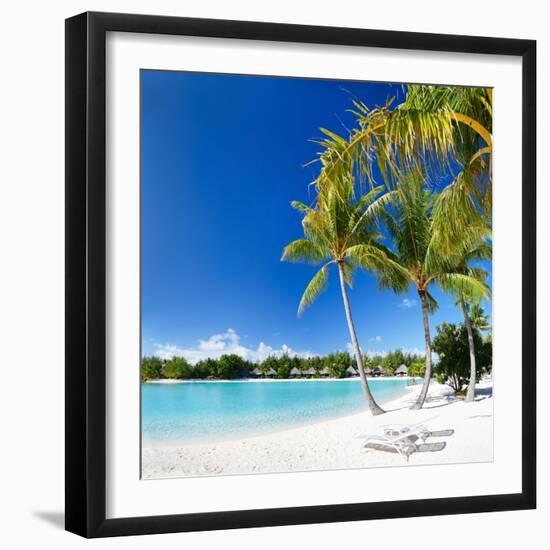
left=141, top=378, right=418, bottom=443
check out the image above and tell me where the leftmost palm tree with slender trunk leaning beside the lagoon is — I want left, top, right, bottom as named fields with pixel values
left=281, top=179, right=400, bottom=415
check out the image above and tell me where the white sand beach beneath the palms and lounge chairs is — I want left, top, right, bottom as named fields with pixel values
left=142, top=380, right=493, bottom=479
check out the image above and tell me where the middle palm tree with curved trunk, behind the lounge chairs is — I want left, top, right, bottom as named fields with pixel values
left=378, top=176, right=485, bottom=409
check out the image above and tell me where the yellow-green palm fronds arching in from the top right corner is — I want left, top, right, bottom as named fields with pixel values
left=317, top=85, right=493, bottom=254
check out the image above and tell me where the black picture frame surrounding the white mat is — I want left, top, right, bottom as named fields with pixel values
left=65, top=13, right=536, bottom=537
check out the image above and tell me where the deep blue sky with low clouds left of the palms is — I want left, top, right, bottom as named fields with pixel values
left=141, top=71, right=492, bottom=361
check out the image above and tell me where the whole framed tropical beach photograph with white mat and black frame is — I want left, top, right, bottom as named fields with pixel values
left=66, top=13, right=536, bottom=537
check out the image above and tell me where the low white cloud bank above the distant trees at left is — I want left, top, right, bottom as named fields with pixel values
left=155, top=328, right=314, bottom=365
